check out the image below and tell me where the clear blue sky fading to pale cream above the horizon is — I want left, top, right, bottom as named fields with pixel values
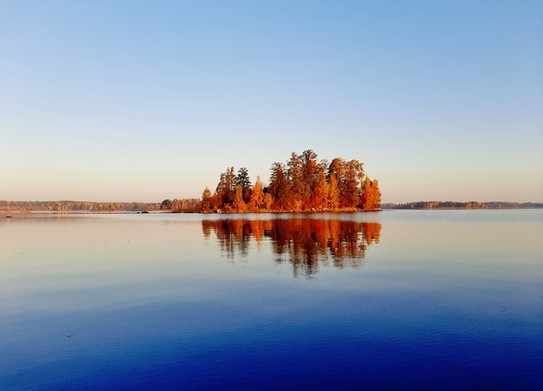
left=0, top=0, right=543, bottom=202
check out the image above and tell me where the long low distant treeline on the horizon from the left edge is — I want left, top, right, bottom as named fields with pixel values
left=0, top=200, right=160, bottom=212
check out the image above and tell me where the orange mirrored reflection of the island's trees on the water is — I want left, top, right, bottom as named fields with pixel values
left=202, top=218, right=381, bottom=276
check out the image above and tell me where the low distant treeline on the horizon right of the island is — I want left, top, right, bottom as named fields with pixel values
left=382, top=201, right=543, bottom=209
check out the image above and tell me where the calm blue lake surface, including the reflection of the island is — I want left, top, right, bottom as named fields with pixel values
left=0, top=210, right=543, bottom=390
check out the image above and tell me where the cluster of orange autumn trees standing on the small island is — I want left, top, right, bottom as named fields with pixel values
left=200, top=149, right=381, bottom=213
